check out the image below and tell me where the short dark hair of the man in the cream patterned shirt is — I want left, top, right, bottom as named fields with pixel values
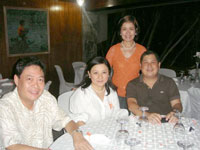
left=14, top=56, right=46, bottom=78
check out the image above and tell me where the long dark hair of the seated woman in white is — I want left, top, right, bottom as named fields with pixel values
left=78, top=57, right=115, bottom=95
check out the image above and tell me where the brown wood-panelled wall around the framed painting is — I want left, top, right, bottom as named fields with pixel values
left=0, top=0, right=82, bottom=94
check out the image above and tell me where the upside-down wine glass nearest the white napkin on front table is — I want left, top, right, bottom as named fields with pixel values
left=116, top=117, right=129, bottom=143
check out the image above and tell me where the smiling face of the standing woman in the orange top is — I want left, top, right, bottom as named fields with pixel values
left=120, top=22, right=136, bottom=42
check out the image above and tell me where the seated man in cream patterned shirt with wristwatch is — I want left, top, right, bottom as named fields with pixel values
left=0, top=57, right=93, bottom=150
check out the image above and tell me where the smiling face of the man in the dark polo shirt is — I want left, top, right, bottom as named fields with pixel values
left=141, top=54, right=160, bottom=78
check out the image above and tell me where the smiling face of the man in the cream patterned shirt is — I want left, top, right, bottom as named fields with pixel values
left=14, top=65, right=45, bottom=108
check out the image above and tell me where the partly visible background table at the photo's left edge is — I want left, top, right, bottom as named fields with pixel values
left=0, top=78, right=15, bottom=98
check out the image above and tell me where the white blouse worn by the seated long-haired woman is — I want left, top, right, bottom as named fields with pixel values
left=70, top=85, right=128, bottom=123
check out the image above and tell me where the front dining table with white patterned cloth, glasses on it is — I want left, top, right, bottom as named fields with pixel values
left=50, top=115, right=200, bottom=150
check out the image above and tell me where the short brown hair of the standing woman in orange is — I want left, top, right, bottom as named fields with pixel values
left=118, top=15, right=140, bottom=40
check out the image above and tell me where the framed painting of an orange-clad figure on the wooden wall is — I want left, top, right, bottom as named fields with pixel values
left=4, top=6, right=50, bottom=56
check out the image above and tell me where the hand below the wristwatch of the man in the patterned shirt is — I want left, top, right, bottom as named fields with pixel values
left=72, top=132, right=94, bottom=150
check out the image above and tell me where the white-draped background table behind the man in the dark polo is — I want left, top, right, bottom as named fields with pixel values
left=174, top=78, right=200, bottom=120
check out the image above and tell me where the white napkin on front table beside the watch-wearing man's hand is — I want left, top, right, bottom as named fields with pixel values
left=84, top=134, right=111, bottom=145
